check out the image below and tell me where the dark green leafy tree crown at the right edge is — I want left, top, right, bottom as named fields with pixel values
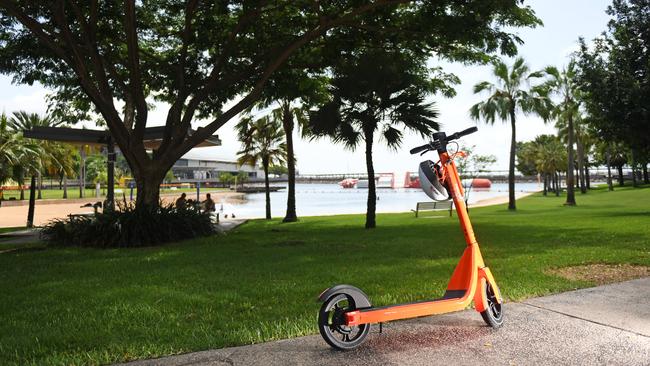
left=578, top=0, right=650, bottom=154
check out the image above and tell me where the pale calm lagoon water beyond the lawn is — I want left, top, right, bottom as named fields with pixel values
left=217, top=183, right=541, bottom=218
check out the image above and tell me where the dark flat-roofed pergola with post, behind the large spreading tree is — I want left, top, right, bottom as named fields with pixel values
left=23, top=126, right=221, bottom=208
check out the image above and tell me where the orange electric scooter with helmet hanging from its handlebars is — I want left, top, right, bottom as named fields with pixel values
left=318, top=127, right=503, bottom=350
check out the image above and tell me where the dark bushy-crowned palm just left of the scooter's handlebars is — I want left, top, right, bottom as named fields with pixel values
left=310, top=48, right=440, bottom=229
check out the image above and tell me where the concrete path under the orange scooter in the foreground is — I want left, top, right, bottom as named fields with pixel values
left=123, top=277, right=650, bottom=366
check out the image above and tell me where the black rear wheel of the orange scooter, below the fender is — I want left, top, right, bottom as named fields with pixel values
left=318, top=294, right=370, bottom=351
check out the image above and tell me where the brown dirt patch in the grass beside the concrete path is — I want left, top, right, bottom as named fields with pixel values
left=547, top=264, right=650, bottom=285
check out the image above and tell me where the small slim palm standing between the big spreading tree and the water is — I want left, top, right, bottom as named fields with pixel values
left=235, top=116, right=287, bottom=220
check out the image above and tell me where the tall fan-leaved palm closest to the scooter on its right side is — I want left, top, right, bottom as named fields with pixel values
left=470, top=57, right=549, bottom=210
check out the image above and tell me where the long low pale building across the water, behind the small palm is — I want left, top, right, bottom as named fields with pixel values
left=172, top=155, right=264, bottom=180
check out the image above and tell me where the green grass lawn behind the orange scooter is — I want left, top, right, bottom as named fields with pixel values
left=0, top=188, right=650, bottom=365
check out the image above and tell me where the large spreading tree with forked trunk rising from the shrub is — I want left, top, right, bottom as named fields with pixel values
left=0, top=0, right=541, bottom=206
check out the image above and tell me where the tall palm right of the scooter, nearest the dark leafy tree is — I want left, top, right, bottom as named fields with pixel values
left=540, top=60, right=580, bottom=206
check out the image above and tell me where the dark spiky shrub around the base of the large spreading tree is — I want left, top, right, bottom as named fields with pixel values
left=41, top=203, right=217, bottom=248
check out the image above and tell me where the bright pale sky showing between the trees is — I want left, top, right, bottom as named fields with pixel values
left=0, top=0, right=611, bottom=177
